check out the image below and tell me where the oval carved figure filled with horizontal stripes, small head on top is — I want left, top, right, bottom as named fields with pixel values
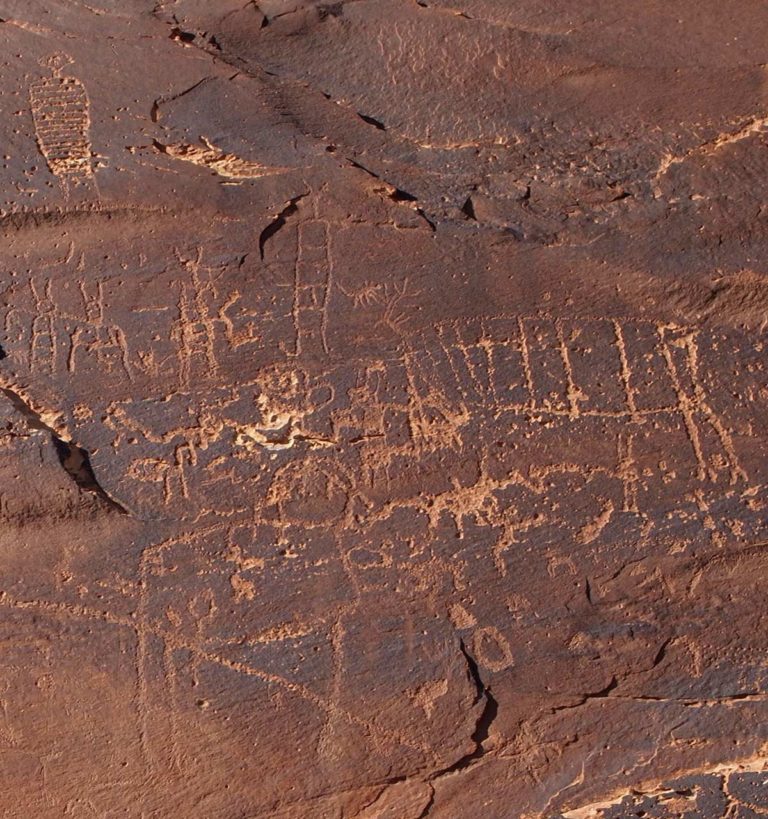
left=29, top=54, right=94, bottom=195
